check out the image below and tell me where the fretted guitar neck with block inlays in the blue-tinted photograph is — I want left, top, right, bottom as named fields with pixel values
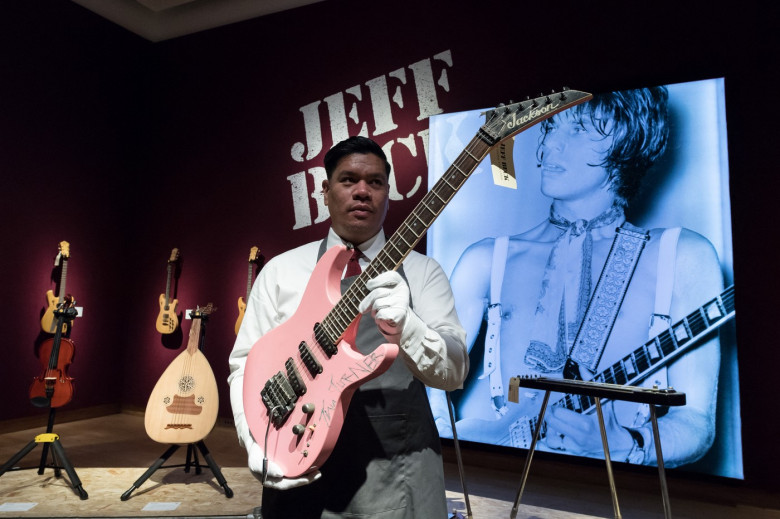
left=554, top=285, right=735, bottom=413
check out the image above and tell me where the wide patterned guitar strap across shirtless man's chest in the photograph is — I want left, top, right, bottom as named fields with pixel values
left=570, top=223, right=650, bottom=373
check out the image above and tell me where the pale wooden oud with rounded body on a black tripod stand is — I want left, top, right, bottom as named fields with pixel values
left=144, top=304, right=219, bottom=444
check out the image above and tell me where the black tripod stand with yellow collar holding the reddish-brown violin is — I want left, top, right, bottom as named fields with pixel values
left=0, top=307, right=89, bottom=500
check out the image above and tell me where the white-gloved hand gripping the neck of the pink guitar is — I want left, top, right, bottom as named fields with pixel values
left=358, top=270, right=410, bottom=336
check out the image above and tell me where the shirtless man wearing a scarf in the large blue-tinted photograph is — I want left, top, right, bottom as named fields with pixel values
left=432, top=88, right=723, bottom=466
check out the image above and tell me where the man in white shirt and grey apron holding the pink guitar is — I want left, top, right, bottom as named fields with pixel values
left=228, top=137, right=468, bottom=519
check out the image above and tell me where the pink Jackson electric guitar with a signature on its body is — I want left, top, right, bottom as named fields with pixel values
left=243, top=90, right=592, bottom=478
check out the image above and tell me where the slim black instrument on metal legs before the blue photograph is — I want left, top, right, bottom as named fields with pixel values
left=510, top=377, right=685, bottom=519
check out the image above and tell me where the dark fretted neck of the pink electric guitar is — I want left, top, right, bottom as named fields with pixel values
left=322, top=132, right=491, bottom=343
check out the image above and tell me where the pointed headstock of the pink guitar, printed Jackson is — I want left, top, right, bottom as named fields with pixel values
left=480, top=88, right=593, bottom=146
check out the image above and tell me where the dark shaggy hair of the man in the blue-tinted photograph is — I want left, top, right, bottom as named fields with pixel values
left=538, top=86, right=669, bottom=205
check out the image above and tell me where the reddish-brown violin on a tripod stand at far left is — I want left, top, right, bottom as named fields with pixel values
left=30, top=296, right=76, bottom=407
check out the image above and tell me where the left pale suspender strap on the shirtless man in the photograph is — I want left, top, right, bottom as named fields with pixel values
left=479, top=236, right=509, bottom=417
